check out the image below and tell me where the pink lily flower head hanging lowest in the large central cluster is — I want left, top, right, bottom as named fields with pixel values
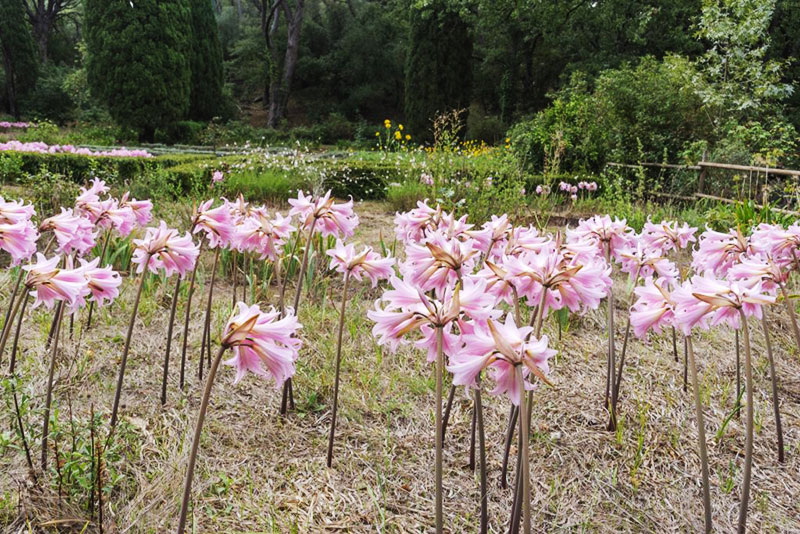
left=447, top=314, right=556, bottom=406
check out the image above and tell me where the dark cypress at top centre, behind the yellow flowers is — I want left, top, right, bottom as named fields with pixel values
left=405, top=0, right=472, bottom=139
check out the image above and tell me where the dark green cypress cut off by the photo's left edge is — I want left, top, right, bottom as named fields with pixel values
left=0, top=0, right=38, bottom=118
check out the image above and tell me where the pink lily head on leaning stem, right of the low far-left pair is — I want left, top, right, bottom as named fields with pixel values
left=131, top=221, right=200, bottom=278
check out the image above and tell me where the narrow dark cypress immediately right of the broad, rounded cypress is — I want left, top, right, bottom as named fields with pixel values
left=189, top=0, right=223, bottom=120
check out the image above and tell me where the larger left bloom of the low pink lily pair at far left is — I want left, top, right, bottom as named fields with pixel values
left=23, top=253, right=90, bottom=309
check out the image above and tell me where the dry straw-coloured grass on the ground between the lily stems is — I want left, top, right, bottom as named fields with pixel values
left=0, top=206, right=800, bottom=533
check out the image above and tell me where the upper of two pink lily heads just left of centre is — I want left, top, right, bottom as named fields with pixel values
left=289, top=191, right=358, bottom=238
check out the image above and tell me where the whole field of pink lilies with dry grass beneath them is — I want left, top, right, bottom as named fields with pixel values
left=0, top=180, right=800, bottom=534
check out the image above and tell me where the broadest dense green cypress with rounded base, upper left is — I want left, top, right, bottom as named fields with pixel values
left=85, top=0, right=192, bottom=141
